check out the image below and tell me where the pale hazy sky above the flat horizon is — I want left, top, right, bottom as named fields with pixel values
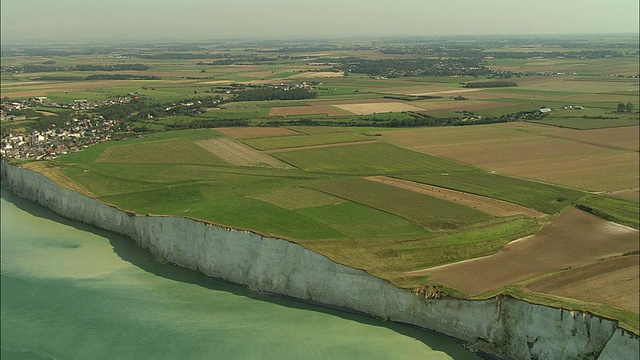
left=0, top=0, right=639, bottom=43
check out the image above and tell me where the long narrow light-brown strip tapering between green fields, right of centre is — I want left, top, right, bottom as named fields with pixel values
left=365, top=176, right=547, bottom=218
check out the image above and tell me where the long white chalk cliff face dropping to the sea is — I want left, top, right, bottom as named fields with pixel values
left=1, top=163, right=640, bottom=359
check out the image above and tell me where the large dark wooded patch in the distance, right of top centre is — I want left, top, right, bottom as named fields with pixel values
left=335, top=58, right=492, bottom=78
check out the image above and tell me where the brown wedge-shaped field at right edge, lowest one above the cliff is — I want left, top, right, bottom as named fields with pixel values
left=525, top=255, right=640, bottom=313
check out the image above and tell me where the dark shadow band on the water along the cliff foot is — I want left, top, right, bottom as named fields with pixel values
left=1, top=186, right=476, bottom=353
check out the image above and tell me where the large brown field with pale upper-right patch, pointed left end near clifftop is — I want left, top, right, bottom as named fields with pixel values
left=407, top=208, right=639, bottom=296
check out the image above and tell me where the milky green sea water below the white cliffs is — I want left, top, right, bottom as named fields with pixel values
left=0, top=188, right=476, bottom=360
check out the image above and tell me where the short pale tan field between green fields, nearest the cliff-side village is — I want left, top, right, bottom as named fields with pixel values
left=196, top=138, right=291, bottom=169
